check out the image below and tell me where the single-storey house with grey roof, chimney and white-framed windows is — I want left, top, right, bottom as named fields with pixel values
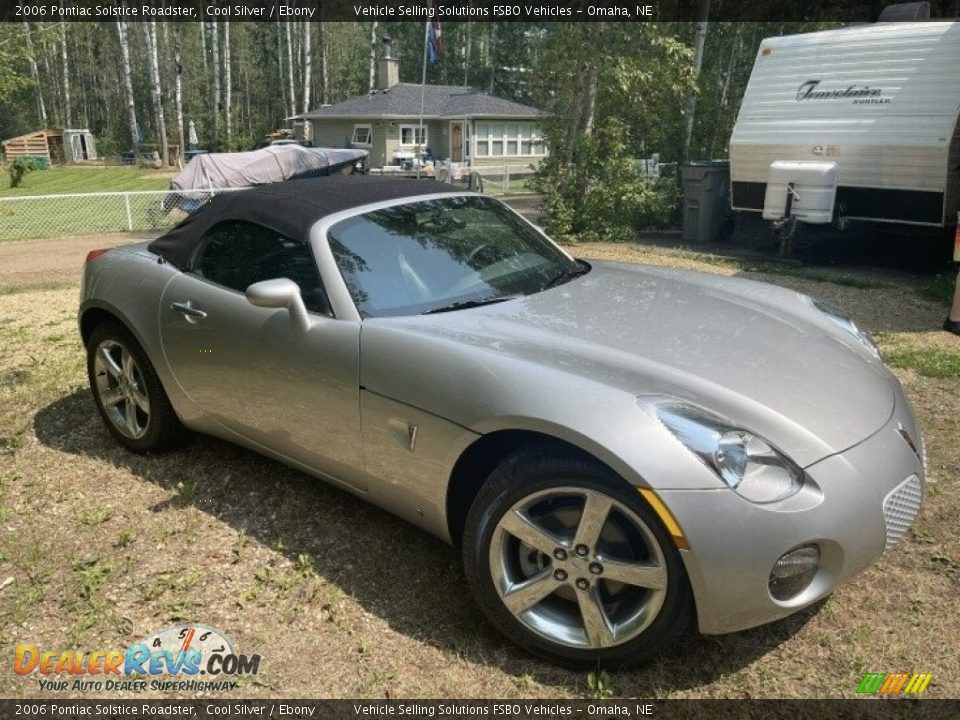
left=294, top=43, right=547, bottom=167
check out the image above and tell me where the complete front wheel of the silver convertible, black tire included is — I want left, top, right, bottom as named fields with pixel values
left=463, top=448, right=691, bottom=668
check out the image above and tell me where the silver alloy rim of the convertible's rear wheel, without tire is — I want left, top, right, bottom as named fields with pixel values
left=93, top=340, right=150, bottom=440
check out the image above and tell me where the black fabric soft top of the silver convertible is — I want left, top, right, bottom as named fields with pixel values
left=147, top=175, right=462, bottom=268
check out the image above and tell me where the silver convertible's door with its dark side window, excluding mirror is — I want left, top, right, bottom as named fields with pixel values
left=160, top=221, right=364, bottom=488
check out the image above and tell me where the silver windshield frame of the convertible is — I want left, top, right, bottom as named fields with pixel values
left=310, top=194, right=579, bottom=321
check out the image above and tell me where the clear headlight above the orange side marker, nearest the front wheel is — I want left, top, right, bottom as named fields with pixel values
left=649, top=400, right=803, bottom=503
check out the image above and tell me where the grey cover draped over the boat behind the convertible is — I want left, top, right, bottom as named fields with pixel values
left=170, top=145, right=368, bottom=190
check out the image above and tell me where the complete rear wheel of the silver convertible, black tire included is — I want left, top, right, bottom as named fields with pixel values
left=87, top=322, right=186, bottom=453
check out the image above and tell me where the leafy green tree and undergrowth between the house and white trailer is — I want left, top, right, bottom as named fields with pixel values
left=536, top=23, right=694, bottom=240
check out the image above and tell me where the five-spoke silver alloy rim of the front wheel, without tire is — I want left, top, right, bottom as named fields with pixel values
left=489, top=487, right=668, bottom=649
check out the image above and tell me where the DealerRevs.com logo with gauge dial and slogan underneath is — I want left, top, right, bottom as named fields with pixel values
left=13, top=625, right=261, bottom=692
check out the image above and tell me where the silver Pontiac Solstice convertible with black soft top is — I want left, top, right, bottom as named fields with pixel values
left=79, top=177, right=924, bottom=667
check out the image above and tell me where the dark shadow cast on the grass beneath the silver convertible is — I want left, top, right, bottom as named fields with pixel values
left=34, top=390, right=817, bottom=697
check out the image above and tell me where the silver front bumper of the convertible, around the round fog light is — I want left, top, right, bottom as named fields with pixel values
left=659, top=392, right=924, bottom=634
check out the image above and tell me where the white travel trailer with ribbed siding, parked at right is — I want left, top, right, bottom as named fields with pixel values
left=730, top=22, right=960, bottom=233
